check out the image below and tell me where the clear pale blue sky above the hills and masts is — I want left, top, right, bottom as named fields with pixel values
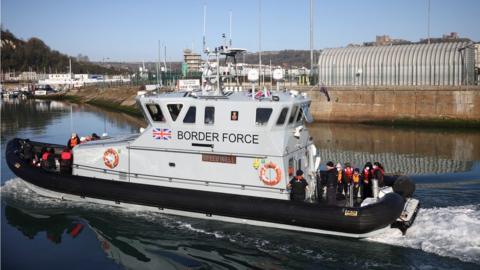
left=1, top=0, right=480, bottom=62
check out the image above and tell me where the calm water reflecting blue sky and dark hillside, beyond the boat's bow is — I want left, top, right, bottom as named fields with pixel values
left=0, top=99, right=146, bottom=143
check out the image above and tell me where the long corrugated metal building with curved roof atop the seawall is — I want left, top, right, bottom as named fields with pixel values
left=318, top=42, right=475, bottom=86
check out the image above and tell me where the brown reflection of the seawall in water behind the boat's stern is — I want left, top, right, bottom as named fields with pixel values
left=310, top=123, right=480, bottom=174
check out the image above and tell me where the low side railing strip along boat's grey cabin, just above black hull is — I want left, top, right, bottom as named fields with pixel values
left=73, top=164, right=288, bottom=194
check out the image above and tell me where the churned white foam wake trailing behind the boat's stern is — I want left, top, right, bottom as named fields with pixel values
left=367, top=205, right=480, bottom=264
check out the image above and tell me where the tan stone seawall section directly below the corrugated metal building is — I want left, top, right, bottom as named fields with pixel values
left=299, top=86, right=480, bottom=122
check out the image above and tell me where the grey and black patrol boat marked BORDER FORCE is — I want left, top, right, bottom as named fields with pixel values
left=6, top=46, right=418, bottom=238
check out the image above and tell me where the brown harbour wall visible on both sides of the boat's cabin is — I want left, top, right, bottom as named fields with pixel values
left=54, top=86, right=480, bottom=127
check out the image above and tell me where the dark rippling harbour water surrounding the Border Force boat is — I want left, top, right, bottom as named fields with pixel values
left=1, top=100, right=480, bottom=269
